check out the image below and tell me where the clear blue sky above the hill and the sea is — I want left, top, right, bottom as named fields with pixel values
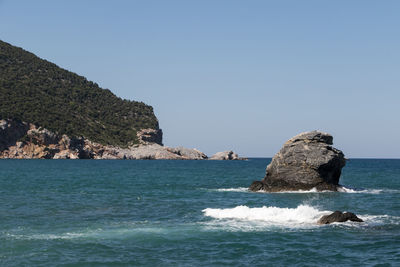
left=0, top=0, right=400, bottom=158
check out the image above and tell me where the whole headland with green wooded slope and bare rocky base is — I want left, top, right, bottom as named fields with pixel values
left=0, top=40, right=244, bottom=160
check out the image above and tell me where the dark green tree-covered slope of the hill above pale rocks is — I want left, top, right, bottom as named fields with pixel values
left=0, top=41, right=159, bottom=146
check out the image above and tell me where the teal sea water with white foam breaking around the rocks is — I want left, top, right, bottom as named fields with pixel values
left=0, top=159, right=400, bottom=266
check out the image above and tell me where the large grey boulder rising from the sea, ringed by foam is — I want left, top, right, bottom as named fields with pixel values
left=249, top=131, right=346, bottom=192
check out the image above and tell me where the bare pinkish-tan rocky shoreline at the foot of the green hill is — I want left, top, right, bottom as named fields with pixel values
left=0, top=120, right=219, bottom=160
